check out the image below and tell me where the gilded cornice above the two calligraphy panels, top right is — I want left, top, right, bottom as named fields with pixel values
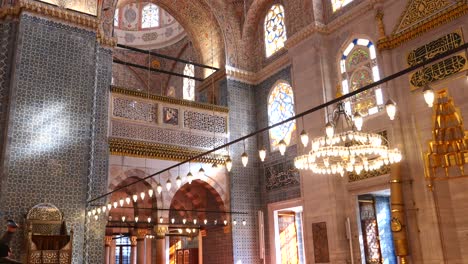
left=377, top=2, right=468, bottom=49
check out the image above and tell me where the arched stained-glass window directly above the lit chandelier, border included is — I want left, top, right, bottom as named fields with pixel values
left=340, top=39, right=383, bottom=116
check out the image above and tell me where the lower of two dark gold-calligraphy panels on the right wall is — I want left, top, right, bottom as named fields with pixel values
left=409, top=52, right=468, bottom=91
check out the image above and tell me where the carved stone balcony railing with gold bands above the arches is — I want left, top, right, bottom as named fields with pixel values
left=109, top=86, right=228, bottom=162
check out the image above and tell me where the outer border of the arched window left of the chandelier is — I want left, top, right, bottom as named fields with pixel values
left=266, top=79, right=297, bottom=151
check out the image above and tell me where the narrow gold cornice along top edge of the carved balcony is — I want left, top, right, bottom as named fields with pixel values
left=111, top=86, right=229, bottom=113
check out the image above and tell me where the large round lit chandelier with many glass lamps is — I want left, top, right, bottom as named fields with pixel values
left=294, top=102, right=402, bottom=177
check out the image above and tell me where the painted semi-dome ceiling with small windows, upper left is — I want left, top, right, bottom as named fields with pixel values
left=114, top=2, right=187, bottom=49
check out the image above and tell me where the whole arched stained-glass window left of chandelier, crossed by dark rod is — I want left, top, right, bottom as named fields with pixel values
left=268, top=81, right=296, bottom=149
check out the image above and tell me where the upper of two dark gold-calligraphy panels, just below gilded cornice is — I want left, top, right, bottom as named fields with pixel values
left=406, top=29, right=463, bottom=66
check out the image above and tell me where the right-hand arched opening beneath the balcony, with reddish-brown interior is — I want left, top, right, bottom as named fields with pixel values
left=169, top=180, right=233, bottom=264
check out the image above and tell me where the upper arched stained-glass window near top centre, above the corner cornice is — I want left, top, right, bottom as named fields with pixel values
left=265, top=4, right=286, bottom=57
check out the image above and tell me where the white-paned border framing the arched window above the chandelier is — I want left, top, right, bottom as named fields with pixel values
left=338, top=35, right=384, bottom=116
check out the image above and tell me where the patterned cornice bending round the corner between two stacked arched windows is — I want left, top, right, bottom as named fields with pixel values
left=226, top=54, right=291, bottom=85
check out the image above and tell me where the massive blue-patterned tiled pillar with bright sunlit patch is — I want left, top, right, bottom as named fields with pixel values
left=0, top=14, right=111, bottom=264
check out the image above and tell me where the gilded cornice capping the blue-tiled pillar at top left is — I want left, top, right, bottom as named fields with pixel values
left=0, top=0, right=117, bottom=47
